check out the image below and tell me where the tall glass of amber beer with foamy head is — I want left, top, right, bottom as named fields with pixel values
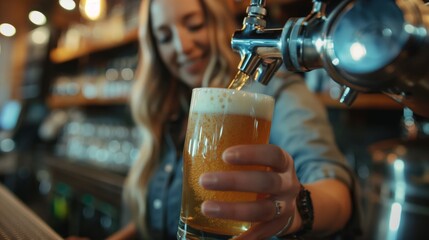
left=178, top=88, right=274, bottom=239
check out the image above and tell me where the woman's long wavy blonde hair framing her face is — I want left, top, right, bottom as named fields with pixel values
left=124, top=0, right=238, bottom=235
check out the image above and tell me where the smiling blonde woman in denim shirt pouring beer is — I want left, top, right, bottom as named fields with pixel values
left=111, top=0, right=354, bottom=239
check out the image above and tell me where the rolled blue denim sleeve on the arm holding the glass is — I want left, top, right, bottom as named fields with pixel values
left=270, top=79, right=361, bottom=239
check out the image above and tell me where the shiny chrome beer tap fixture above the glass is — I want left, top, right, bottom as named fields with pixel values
left=231, top=0, right=429, bottom=117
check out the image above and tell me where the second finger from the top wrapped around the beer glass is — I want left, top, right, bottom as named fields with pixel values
left=199, top=171, right=287, bottom=194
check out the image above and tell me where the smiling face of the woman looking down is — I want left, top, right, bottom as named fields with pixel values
left=150, top=0, right=211, bottom=87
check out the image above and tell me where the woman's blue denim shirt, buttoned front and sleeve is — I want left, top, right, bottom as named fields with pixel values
left=147, top=75, right=359, bottom=240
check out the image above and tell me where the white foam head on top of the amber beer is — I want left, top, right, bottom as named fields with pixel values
left=190, top=88, right=274, bottom=121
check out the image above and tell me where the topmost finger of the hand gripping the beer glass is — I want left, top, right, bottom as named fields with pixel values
left=222, top=144, right=292, bottom=172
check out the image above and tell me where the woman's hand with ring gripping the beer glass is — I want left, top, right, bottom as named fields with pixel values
left=200, top=144, right=300, bottom=239
